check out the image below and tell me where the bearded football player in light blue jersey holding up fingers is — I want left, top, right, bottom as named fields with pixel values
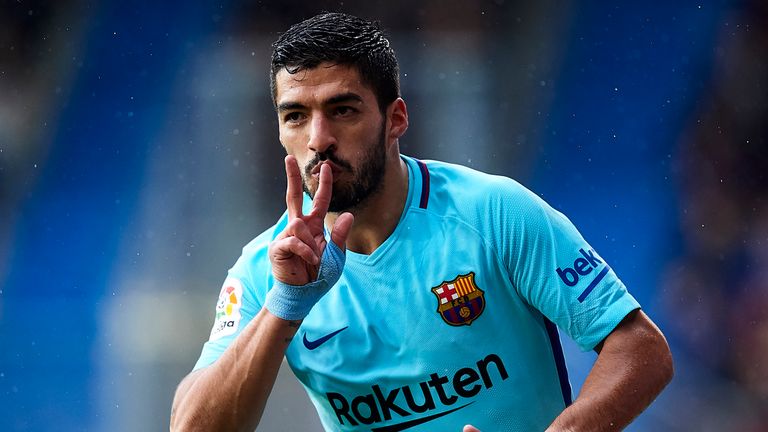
left=171, top=14, right=672, bottom=432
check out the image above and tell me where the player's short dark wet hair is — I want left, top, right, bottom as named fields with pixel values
left=270, top=13, right=400, bottom=112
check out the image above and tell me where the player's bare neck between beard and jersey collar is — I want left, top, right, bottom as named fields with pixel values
left=325, top=152, right=408, bottom=255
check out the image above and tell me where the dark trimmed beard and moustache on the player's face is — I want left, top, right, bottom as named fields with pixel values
left=302, top=121, right=387, bottom=213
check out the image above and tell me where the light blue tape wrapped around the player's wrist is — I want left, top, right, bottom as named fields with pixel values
left=264, top=241, right=346, bottom=320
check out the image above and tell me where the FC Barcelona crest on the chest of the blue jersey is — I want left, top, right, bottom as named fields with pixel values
left=432, top=272, right=485, bottom=326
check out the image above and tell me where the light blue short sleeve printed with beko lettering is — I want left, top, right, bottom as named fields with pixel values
left=502, top=186, right=640, bottom=351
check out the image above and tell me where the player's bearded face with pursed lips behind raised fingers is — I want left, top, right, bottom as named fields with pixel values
left=275, top=63, right=387, bottom=212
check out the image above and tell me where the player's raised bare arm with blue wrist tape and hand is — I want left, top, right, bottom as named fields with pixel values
left=171, top=156, right=353, bottom=431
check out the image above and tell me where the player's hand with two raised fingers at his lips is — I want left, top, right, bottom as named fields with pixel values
left=268, top=155, right=354, bottom=286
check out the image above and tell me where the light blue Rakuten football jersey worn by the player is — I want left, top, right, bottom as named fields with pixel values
left=195, top=156, right=639, bottom=432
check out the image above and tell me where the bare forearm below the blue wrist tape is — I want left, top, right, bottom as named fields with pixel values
left=171, top=309, right=299, bottom=431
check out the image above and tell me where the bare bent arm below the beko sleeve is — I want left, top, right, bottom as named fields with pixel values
left=547, top=311, right=673, bottom=432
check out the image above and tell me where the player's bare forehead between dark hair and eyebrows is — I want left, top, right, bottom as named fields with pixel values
left=275, top=63, right=375, bottom=105
